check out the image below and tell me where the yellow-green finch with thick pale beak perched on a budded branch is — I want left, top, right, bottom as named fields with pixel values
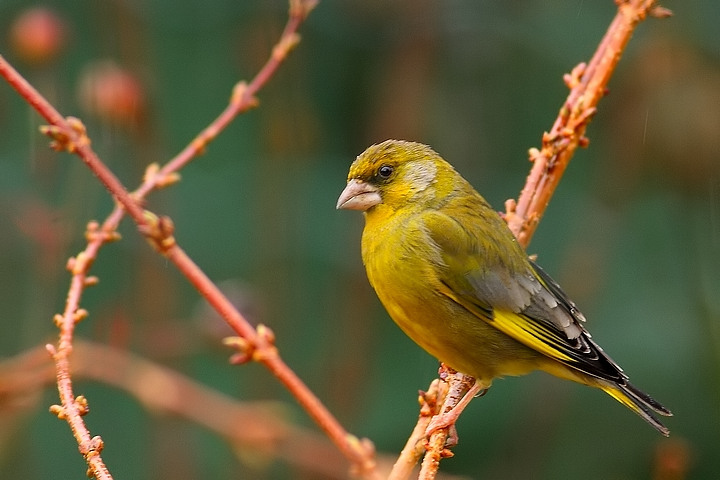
left=337, top=140, right=672, bottom=436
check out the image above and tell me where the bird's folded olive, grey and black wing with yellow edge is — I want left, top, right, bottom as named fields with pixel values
left=429, top=215, right=626, bottom=382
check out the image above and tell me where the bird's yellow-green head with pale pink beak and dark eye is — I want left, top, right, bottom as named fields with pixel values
left=337, top=140, right=457, bottom=212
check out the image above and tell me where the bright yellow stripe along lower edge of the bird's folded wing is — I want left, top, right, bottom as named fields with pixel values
left=490, top=310, right=575, bottom=363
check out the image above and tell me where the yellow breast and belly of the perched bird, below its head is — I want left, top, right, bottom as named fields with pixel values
left=362, top=205, right=537, bottom=385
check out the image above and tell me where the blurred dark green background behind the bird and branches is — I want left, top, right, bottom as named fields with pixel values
left=0, top=0, right=720, bottom=479
